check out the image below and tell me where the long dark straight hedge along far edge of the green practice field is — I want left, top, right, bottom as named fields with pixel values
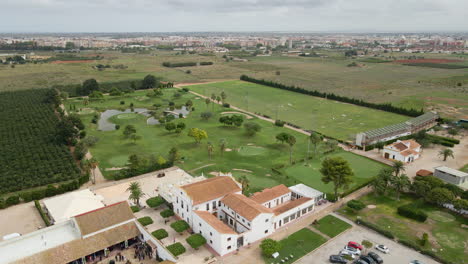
left=240, top=75, right=424, bottom=117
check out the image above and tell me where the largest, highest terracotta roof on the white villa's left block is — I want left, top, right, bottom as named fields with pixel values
left=181, top=176, right=242, bottom=205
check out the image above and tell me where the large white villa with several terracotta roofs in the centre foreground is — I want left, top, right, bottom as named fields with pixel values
left=170, top=176, right=324, bottom=256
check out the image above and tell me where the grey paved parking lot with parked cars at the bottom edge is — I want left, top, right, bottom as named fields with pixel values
left=296, top=221, right=439, bottom=264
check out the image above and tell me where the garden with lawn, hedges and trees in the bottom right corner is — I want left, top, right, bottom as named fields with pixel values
left=339, top=193, right=468, bottom=263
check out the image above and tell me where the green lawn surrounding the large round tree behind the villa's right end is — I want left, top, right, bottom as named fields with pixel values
left=284, top=151, right=386, bottom=193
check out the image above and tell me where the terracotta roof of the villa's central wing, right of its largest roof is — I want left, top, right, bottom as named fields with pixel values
left=221, top=194, right=272, bottom=221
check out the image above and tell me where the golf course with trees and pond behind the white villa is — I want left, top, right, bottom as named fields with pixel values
left=65, top=88, right=384, bottom=192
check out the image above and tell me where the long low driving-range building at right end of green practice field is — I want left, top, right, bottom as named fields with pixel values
left=356, top=111, right=439, bottom=147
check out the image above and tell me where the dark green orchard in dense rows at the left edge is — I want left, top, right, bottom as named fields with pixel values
left=0, top=89, right=80, bottom=194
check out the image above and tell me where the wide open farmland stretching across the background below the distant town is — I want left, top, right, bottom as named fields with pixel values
left=0, top=51, right=468, bottom=118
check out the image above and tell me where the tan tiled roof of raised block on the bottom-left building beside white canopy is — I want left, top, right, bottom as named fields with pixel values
left=75, top=201, right=135, bottom=236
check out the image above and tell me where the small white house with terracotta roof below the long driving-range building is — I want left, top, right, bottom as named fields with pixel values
left=382, top=139, right=421, bottom=163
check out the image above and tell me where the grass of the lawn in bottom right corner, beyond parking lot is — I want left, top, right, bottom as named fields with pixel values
left=339, top=194, right=468, bottom=263
